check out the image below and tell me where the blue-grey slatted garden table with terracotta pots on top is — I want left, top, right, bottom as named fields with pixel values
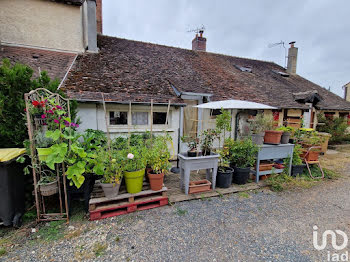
left=252, top=144, right=294, bottom=183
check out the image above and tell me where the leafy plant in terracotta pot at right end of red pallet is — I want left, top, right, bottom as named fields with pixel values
left=147, top=135, right=171, bottom=191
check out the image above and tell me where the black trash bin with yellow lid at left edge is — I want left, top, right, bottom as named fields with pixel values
left=0, top=148, right=25, bottom=227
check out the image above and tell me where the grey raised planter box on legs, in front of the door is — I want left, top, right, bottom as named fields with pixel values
left=178, top=153, right=219, bottom=195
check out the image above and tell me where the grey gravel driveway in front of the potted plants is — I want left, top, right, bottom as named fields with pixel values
left=1, top=167, right=350, bottom=262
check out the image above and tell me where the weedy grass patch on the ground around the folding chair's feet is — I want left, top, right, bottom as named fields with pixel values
left=266, top=165, right=339, bottom=192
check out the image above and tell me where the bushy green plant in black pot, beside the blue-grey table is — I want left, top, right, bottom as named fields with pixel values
left=225, top=138, right=259, bottom=185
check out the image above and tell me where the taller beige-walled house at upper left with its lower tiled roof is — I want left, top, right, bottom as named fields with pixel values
left=0, top=0, right=102, bottom=81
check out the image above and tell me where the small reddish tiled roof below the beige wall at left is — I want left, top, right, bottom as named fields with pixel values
left=0, top=45, right=76, bottom=80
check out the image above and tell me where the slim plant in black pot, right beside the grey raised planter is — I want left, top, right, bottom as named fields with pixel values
left=216, top=147, right=234, bottom=188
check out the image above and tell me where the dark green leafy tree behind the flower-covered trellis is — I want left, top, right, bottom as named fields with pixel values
left=0, top=59, right=77, bottom=148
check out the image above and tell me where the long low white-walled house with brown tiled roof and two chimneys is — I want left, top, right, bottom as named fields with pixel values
left=62, top=33, right=350, bottom=150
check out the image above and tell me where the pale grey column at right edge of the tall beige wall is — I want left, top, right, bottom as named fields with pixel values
left=86, top=0, right=98, bottom=53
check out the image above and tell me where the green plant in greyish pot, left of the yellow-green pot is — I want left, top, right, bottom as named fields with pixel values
left=93, top=147, right=124, bottom=198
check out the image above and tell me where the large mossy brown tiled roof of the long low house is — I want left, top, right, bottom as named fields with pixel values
left=64, top=36, right=350, bottom=110
